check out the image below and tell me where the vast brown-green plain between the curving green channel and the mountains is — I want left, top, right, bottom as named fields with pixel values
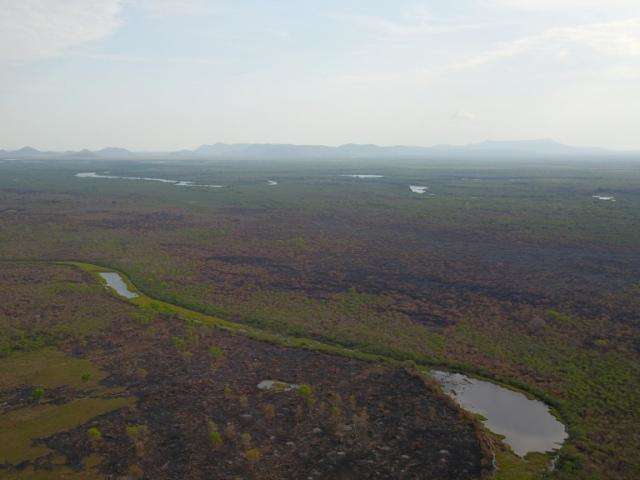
left=0, top=157, right=640, bottom=479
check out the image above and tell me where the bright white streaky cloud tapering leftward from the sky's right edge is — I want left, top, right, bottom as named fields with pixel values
left=450, top=18, right=640, bottom=70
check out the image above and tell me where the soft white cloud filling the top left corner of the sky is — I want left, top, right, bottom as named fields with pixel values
left=0, top=0, right=121, bottom=61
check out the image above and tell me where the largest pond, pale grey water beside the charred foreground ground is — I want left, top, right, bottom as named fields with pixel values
left=432, top=371, right=567, bottom=456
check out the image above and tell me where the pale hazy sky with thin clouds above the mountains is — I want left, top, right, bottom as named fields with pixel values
left=0, top=0, right=640, bottom=150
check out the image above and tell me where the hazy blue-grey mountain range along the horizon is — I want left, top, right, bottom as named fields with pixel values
left=0, top=139, right=640, bottom=160
